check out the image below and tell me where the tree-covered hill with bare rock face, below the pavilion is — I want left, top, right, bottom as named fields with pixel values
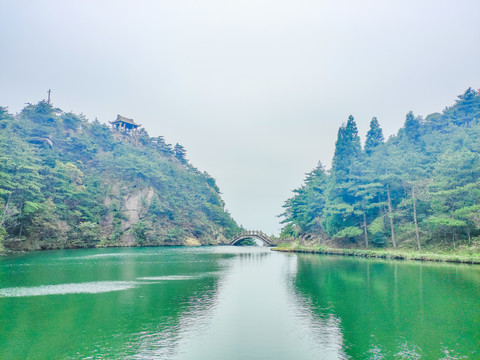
left=0, top=101, right=239, bottom=250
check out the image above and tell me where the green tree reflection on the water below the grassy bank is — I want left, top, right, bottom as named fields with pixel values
left=294, top=255, right=480, bottom=359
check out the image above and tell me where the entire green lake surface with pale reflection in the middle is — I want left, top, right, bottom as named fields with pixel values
left=0, top=246, right=480, bottom=360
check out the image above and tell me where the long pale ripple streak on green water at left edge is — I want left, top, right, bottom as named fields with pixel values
left=0, top=281, right=137, bottom=297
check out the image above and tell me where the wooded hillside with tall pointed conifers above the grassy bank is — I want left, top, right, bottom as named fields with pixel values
left=282, top=88, right=480, bottom=250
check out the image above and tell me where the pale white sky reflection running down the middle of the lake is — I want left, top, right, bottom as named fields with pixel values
left=159, top=248, right=345, bottom=360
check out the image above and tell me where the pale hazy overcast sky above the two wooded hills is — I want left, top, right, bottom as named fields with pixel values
left=0, top=0, right=480, bottom=234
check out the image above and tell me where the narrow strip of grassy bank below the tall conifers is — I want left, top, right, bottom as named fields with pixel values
left=272, top=243, right=480, bottom=265
